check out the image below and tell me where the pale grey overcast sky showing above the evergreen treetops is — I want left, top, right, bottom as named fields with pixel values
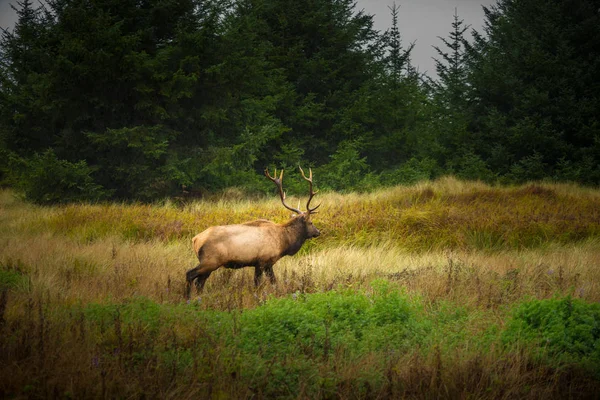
left=0, top=0, right=496, bottom=76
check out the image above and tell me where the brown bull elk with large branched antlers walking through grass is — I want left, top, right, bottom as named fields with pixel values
left=186, top=168, right=321, bottom=299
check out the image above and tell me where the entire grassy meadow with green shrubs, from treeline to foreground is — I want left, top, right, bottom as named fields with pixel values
left=0, top=178, right=600, bottom=399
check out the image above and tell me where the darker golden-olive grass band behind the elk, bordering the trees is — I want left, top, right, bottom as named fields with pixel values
left=3, top=178, right=600, bottom=251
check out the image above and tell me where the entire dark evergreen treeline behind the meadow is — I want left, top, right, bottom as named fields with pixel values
left=0, top=0, right=600, bottom=202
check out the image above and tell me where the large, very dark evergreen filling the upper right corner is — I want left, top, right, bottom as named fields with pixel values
left=469, top=0, right=600, bottom=182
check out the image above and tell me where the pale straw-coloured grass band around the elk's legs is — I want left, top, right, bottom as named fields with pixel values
left=0, top=228, right=600, bottom=309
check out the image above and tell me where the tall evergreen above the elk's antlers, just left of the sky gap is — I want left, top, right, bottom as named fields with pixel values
left=239, top=0, right=376, bottom=164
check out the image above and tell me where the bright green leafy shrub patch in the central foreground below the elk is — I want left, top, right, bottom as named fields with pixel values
left=240, top=282, right=422, bottom=357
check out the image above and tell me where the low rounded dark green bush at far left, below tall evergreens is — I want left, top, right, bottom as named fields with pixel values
left=10, top=149, right=109, bottom=204
